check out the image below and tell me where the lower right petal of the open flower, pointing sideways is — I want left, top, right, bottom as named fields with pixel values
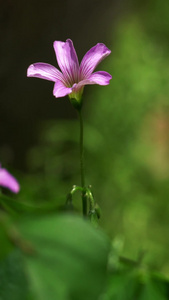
left=73, top=71, right=112, bottom=90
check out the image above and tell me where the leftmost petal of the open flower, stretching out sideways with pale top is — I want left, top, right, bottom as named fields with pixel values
left=27, top=63, right=64, bottom=82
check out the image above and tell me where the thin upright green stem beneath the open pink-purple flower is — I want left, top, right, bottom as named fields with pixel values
left=78, top=109, right=87, bottom=217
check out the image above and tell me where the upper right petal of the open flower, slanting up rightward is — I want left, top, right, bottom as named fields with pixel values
left=80, top=43, right=111, bottom=79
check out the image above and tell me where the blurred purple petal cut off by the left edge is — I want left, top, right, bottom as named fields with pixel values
left=0, top=164, right=20, bottom=193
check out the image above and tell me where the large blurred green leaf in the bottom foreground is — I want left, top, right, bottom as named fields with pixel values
left=21, top=215, right=109, bottom=300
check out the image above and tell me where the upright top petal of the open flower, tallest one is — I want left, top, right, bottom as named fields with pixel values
left=53, top=39, right=79, bottom=86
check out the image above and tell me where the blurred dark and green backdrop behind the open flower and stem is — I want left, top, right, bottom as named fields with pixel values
left=0, top=0, right=169, bottom=276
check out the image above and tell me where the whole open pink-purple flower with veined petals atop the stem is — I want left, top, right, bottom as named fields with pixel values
left=27, top=39, right=112, bottom=102
